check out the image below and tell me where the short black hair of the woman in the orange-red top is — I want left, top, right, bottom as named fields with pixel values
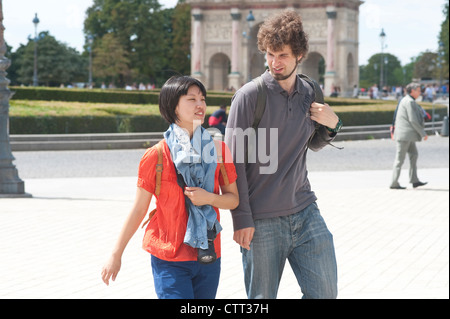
left=159, top=76, right=206, bottom=124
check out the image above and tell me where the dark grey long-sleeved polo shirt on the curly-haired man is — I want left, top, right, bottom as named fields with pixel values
left=225, top=71, right=334, bottom=230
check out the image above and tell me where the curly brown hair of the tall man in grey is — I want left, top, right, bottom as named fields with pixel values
left=258, top=10, right=309, bottom=61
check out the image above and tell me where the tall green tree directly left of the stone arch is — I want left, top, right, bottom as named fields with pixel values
left=84, top=0, right=172, bottom=86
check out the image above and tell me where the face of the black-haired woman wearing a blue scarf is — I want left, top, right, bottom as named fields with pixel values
left=175, top=85, right=206, bottom=134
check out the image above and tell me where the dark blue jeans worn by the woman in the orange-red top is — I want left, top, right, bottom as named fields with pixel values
left=152, top=256, right=220, bottom=299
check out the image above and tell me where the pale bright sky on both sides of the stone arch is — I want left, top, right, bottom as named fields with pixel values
left=2, top=0, right=447, bottom=65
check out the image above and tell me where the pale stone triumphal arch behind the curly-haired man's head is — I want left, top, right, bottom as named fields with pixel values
left=186, top=0, right=362, bottom=96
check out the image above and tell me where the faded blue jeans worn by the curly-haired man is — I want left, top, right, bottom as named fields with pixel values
left=241, top=203, right=337, bottom=299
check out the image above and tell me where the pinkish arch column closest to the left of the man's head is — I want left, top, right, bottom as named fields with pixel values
left=228, top=8, right=242, bottom=90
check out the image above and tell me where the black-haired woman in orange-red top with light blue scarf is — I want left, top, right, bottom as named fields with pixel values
left=102, top=76, right=239, bottom=299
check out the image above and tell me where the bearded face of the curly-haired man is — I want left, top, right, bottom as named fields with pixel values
left=267, top=45, right=301, bottom=81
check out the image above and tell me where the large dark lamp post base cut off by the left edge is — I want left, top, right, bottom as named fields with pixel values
left=0, top=0, right=31, bottom=197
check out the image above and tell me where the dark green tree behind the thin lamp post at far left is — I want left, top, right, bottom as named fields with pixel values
left=12, top=31, right=88, bottom=86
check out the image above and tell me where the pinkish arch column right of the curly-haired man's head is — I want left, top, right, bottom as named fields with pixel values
left=324, top=6, right=337, bottom=96
